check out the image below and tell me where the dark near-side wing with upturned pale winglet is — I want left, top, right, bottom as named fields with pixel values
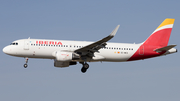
left=74, top=25, right=120, bottom=57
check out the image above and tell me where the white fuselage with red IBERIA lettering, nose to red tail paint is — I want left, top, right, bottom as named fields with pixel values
left=3, top=39, right=141, bottom=62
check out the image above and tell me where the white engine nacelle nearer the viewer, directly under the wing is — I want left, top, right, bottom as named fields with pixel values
left=53, top=51, right=80, bottom=62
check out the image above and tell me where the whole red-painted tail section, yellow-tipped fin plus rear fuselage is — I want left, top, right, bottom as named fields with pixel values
left=128, top=18, right=177, bottom=61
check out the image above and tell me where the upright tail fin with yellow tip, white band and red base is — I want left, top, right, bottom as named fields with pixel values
left=143, top=18, right=175, bottom=47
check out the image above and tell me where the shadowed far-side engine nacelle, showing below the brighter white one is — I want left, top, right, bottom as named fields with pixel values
left=54, top=60, right=77, bottom=68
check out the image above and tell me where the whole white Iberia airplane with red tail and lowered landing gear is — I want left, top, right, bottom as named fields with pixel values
left=3, top=18, right=177, bottom=73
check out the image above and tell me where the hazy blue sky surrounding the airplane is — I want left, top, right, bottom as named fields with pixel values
left=0, top=0, right=180, bottom=101
